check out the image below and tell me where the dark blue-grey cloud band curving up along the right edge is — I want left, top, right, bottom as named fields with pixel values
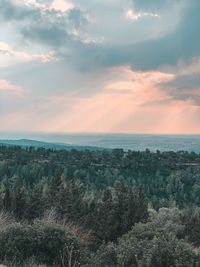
left=57, top=0, right=200, bottom=71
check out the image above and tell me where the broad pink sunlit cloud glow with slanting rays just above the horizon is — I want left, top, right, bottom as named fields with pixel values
left=0, top=66, right=200, bottom=133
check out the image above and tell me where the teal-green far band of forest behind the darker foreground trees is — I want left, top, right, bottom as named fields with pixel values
left=0, top=146, right=200, bottom=210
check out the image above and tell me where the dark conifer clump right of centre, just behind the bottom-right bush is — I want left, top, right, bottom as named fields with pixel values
left=87, top=182, right=148, bottom=245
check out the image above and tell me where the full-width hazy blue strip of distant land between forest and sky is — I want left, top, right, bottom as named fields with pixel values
left=0, top=134, right=200, bottom=153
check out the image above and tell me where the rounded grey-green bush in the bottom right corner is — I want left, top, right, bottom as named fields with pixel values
left=86, top=223, right=200, bottom=267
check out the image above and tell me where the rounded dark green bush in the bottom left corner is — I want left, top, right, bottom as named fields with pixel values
left=0, top=221, right=80, bottom=266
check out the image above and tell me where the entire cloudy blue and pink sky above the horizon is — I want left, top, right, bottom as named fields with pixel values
left=0, top=0, right=200, bottom=134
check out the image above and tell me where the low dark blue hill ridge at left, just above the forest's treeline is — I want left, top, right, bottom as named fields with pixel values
left=0, top=139, right=111, bottom=151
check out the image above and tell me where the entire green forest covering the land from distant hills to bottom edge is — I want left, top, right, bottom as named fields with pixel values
left=0, top=145, right=200, bottom=267
